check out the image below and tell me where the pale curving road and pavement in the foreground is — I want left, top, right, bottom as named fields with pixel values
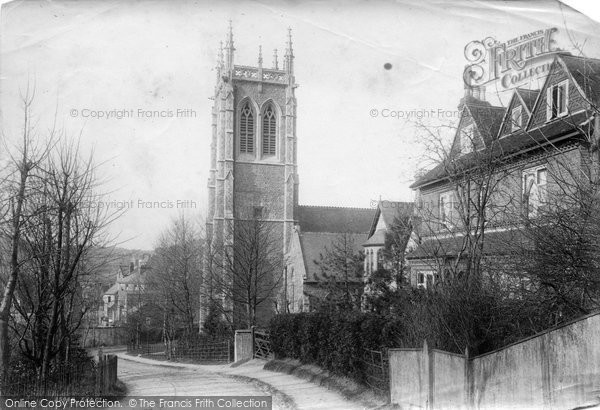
left=116, top=351, right=364, bottom=410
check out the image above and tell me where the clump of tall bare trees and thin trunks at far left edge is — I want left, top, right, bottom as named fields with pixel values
left=0, top=90, right=120, bottom=390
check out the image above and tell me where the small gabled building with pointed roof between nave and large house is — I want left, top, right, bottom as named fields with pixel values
left=363, top=200, right=418, bottom=293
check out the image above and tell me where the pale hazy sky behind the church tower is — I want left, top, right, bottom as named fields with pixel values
left=0, top=0, right=600, bottom=249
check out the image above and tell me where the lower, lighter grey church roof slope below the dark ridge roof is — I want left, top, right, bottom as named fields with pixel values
left=299, top=232, right=367, bottom=282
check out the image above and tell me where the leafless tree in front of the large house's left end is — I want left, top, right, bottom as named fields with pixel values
left=417, top=101, right=519, bottom=282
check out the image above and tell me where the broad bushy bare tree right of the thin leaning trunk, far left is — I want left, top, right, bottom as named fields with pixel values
left=14, top=139, right=119, bottom=380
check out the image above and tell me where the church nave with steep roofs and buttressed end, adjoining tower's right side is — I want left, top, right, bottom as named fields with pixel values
left=283, top=206, right=375, bottom=312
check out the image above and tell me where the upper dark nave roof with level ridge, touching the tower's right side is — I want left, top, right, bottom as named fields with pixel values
left=295, top=205, right=375, bottom=233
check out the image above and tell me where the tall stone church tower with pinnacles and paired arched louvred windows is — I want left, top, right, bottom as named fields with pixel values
left=200, top=23, right=298, bottom=323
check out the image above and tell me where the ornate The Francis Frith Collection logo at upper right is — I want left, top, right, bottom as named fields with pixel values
left=463, top=27, right=561, bottom=89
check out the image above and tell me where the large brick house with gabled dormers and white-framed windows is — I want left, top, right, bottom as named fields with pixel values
left=408, top=54, right=600, bottom=287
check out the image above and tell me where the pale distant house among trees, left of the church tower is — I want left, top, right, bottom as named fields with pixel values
left=100, top=255, right=150, bottom=326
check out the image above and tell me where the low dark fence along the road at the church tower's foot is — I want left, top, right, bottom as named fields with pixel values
left=127, top=339, right=232, bottom=363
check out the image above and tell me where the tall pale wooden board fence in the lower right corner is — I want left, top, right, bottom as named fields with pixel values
left=389, top=313, right=600, bottom=409
